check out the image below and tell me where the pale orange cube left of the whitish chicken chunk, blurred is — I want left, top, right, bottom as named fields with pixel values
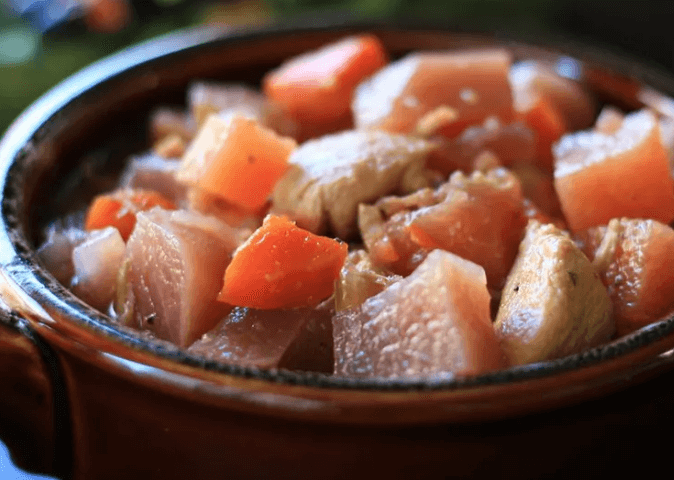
left=178, top=115, right=297, bottom=212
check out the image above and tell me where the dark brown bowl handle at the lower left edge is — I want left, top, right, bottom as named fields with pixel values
left=0, top=295, right=71, bottom=476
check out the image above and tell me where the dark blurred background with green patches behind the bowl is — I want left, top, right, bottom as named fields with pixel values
left=0, top=0, right=674, bottom=132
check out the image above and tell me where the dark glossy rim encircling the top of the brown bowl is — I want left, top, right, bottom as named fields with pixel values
left=0, top=18, right=674, bottom=391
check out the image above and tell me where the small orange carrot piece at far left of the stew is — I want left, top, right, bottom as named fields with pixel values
left=84, top=190, right=176, bottom=241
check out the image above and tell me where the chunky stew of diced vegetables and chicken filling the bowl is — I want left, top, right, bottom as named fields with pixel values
left=38, top=35, right=674, bottom=377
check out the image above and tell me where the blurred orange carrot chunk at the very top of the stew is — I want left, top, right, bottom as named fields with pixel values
left=263, top=35, right=388, bottom=123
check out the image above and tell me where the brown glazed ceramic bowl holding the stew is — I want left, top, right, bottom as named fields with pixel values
left=0, top=18, right=674, bottom=480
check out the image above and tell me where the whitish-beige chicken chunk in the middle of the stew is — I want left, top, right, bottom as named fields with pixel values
left=272, top=131, right=431, bottom=239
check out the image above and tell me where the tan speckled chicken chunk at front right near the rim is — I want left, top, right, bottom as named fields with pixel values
left=494, top=221, right=615, bottom=364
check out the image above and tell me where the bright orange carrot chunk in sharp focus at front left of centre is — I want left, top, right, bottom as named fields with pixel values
left=218, top=215, right=348, bottom=309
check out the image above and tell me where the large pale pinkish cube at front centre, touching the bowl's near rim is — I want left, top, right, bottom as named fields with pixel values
left=333, top=250, right=505, bottom=377
